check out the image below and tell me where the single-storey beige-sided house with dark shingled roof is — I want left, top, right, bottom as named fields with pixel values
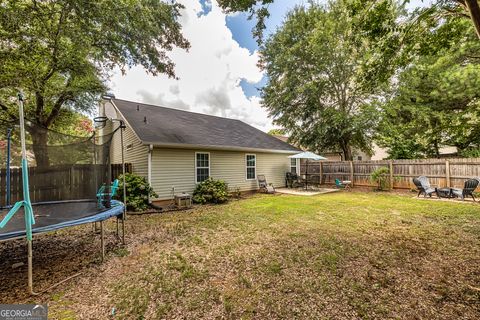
left=100, top=98, right=300, bottom=200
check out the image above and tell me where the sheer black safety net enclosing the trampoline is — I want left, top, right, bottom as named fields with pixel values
left=0, top=120, right=115, bottom=208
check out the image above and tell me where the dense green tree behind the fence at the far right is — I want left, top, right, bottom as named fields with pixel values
left=377, top=17, right=480, bottom=158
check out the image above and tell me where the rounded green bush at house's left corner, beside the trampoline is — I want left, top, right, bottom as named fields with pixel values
left=117, top=173, right=157, bottom=211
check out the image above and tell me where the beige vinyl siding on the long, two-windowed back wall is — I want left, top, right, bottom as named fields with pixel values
left=152, top=148, right=290, bottom=199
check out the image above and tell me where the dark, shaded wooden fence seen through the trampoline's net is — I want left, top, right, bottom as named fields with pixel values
left=0, top=163, right=132, bottom=207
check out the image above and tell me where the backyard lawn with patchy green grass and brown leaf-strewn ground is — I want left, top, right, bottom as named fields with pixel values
left=0, top=192, right=480, bottom=319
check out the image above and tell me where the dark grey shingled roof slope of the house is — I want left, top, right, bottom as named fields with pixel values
left=112, top=99, right=299, bottom=153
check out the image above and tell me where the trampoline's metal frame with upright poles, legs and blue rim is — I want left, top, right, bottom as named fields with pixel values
left=0, top=92, right=127, bottom=295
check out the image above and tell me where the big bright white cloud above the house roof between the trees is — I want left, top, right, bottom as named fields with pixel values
left=111, top=0, right=272, bottom=130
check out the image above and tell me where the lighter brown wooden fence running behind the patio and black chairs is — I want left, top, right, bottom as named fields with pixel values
left=300, top=158, right=480, bottom=189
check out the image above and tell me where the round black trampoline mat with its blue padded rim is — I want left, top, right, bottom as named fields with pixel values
left=0, top=200, right=123, bottom=241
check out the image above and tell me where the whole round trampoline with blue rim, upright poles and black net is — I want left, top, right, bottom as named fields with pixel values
left=0, top=94, right=126, bottom=294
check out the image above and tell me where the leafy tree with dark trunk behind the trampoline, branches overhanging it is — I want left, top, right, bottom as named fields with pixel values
left=0, top=0, right=189, bottom=166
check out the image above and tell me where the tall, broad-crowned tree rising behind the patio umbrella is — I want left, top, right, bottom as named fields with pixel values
left=260, top=0, right=400, bottom=160
